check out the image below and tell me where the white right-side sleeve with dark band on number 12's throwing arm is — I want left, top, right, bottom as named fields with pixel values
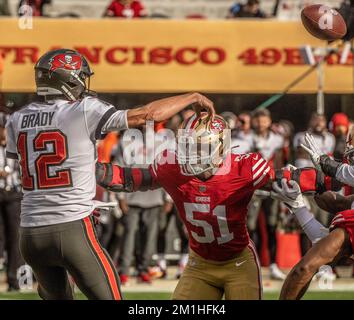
left=83, top=97, right=127, bottom=140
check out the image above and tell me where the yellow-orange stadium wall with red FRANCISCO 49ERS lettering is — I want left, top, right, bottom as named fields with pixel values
left=0, top=18, right=353, bottom=94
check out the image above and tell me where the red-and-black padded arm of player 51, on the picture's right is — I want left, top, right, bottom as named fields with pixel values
left=275, top=168, right=342, bottom=194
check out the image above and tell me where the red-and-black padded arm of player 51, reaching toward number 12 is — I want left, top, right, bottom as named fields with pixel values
left=96, top=162, right=159, bottom=192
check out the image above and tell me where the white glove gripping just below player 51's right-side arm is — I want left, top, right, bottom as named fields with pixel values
left=271, top=179, right=306, bottom=211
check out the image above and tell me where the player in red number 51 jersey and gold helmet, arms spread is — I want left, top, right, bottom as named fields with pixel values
left=96, top=114, right=338, bottom=300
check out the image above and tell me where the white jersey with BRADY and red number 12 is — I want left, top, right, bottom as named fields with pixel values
left=6, top=97, right=127, bottom=227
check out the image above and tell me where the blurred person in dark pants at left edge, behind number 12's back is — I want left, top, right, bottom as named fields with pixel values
left=0, top=113, right=24, bottom=291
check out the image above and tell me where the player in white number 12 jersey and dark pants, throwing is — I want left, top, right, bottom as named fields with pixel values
left=7, top=49, right=215, bottom=300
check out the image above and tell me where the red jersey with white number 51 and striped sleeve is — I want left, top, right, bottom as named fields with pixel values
left=150, top=153, right=271, bottom=261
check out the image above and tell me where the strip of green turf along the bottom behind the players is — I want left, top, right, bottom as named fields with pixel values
left=0, top=291, right=354, bottom=300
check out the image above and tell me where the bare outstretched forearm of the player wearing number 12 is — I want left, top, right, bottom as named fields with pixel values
left=127, top=93, right=212, bottom=128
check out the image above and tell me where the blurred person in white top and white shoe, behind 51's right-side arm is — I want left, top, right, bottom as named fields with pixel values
left=248, top=109, right=285, bottom=280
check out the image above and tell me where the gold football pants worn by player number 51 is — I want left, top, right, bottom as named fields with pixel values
left=173, top=244, right=262, bottom=300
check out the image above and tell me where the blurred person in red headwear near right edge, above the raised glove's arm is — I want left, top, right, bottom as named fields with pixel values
left=329, top=113, right=350, bottom=161
